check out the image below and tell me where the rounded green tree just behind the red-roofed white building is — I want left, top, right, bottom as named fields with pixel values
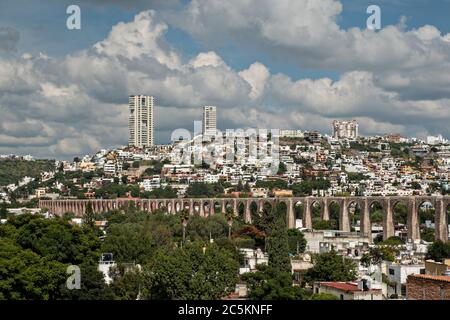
left=304, top=250, right=356, bottom=284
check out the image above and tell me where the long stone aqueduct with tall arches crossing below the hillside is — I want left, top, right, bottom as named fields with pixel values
left=39, top=196, right=450, bottom=241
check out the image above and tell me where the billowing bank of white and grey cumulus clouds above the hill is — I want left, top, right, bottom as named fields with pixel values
left=0, top=0, right=450, bottom=158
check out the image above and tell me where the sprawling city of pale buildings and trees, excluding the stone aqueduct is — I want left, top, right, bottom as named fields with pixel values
left=0, top=96, right=450, bottom=300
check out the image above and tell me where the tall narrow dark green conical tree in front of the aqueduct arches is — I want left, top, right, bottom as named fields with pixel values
left=267, top=216, right=292, bottom=272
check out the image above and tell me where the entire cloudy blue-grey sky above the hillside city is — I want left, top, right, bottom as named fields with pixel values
left=0, top=0, right=450, bottom=159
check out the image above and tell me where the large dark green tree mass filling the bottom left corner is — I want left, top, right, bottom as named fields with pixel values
left=0, top=214, right=112, bottom=300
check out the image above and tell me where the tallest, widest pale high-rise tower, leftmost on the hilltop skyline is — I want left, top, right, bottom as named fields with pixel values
left=128, top=95, right=155, bottom=148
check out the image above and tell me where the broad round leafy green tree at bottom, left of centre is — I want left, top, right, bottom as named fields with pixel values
left=142, top=242, right=239, bottom=300
